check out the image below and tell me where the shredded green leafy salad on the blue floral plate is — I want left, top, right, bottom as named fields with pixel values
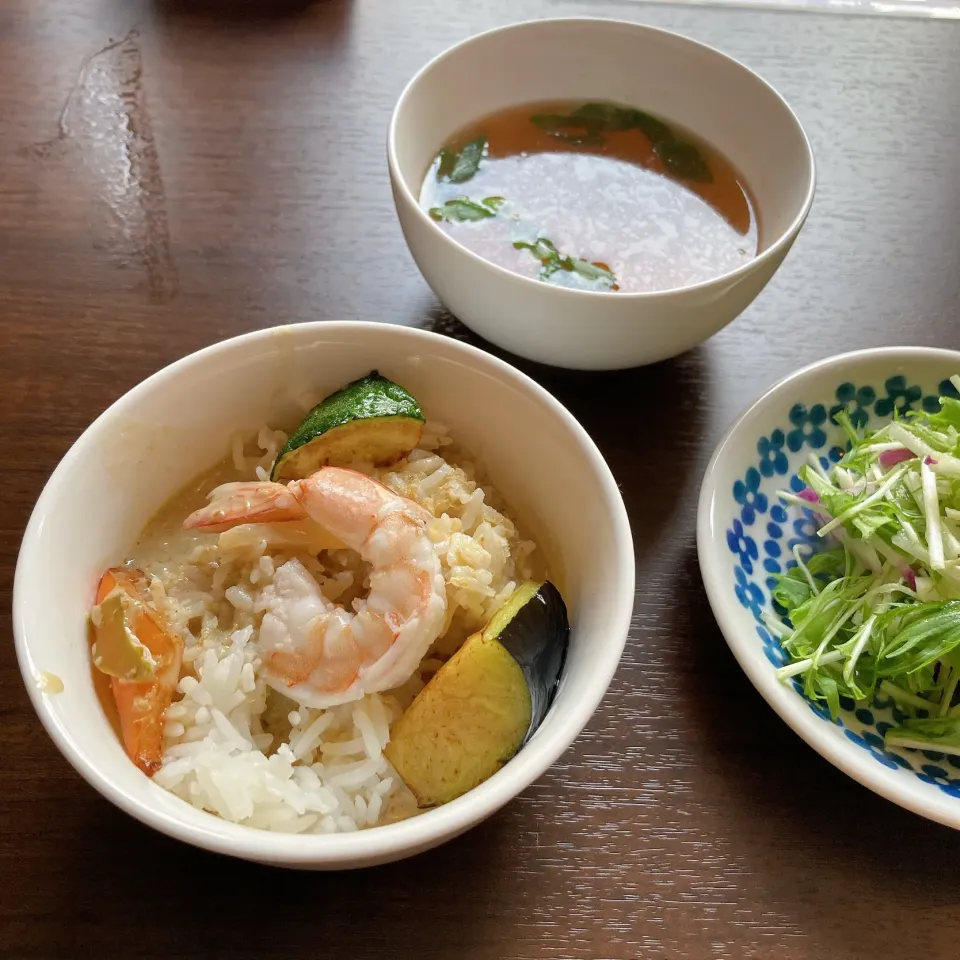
left=764, top=376, right=960, bottom=754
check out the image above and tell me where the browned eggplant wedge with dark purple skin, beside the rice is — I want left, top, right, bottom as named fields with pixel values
left=385, top=582, right=570, bottom=807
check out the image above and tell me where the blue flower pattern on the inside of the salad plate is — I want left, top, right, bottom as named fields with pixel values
left=726, top=376, right=960, bottom=799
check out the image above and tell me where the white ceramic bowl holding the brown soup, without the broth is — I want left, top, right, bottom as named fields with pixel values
left=387, top=19, right=815, bottom=370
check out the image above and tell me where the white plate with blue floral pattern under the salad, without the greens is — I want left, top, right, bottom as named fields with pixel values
left=697, top=347, right=960, bottom=828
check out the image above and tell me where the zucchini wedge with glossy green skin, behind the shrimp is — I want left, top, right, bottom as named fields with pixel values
left=270, top=370, right=423, bottom=482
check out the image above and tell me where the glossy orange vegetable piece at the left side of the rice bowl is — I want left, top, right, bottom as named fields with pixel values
left=96, top=567, right=183, bottom=776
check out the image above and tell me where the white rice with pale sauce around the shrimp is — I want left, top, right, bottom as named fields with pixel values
left=125, top=420, right=534, bottom=833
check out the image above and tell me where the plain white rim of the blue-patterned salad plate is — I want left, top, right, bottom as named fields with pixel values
left=697, top=346, right=960, bottom=829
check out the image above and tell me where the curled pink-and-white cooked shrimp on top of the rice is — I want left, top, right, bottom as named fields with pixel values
left=184, top=467, right=447, bottom=707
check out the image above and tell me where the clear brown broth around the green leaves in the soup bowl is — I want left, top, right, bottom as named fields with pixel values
left=420, top=101, right=759, bottom=292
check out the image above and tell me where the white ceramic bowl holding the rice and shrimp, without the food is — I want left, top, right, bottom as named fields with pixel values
left=13, top=323, right=634, bottom=869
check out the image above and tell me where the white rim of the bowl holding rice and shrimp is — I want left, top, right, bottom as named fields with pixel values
left=13, top=321, right=635, bottom=868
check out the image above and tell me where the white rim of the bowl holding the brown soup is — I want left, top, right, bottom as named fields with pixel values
left=387, top=17, right=817, bottom=303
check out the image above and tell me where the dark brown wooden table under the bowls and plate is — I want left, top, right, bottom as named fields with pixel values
left=0, top=0, right=960, bottom=960
